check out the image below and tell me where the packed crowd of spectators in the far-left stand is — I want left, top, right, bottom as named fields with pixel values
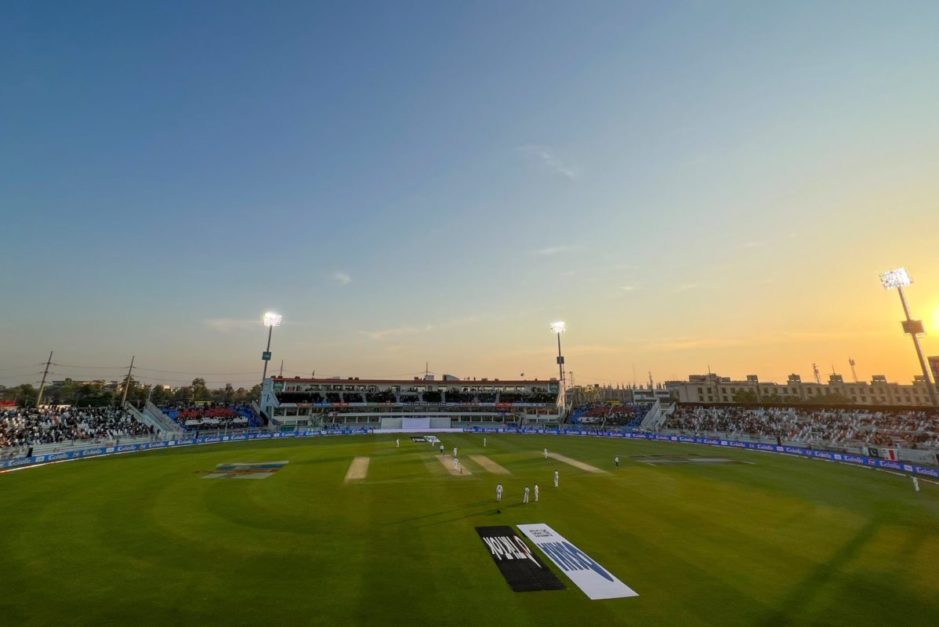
left=0, top=407, right=153, bottom=449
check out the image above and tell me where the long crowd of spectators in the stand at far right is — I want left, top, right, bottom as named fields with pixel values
left=664, top=405, right=939, bottom=449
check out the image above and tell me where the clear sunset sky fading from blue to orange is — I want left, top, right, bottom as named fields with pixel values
left=0, top=1, right=939, bottom=392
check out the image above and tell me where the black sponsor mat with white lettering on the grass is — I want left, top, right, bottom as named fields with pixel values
left=476, top=526, right=564, bottom=592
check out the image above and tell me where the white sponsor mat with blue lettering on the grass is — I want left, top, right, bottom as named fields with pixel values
left=518, top=523, right=639, bottom=600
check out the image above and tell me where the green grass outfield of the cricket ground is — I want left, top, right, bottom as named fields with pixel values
left=0, top=434, right=939, bottom=627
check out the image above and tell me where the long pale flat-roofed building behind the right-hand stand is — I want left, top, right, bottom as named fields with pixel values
left=665, top=374, right=930, bottom=407
